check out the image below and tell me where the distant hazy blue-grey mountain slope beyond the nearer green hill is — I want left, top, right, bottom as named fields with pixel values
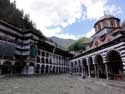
left=49, top=36, right=75, bottom=48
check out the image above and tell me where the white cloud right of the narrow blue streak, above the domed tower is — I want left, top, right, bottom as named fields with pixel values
left=81, top=0, right=121, bottom=20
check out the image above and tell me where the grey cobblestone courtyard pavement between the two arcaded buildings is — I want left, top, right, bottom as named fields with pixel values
left=0, top=75, right=125, bottom=94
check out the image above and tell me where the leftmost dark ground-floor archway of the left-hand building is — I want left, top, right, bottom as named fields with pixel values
left=1, top=61, right=12, bottom=74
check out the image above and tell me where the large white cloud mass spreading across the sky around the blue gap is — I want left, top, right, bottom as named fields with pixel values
left=11, top=0, right=121, bottom=39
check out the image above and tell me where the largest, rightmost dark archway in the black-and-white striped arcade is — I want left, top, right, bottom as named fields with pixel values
left=107, top=51, right=123, bottom=79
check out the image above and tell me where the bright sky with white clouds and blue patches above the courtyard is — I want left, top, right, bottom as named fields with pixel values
left=10, top=0, right=125, bottom=40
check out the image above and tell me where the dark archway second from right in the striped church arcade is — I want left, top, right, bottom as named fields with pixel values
left=95, top=55, right=106, bottom=78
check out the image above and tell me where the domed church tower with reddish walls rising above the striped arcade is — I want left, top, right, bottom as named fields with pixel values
left=90, top=14, right=121, bottom=48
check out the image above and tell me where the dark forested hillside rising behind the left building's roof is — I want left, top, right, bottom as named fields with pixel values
left=0, top=0, right=35, bottom=30
